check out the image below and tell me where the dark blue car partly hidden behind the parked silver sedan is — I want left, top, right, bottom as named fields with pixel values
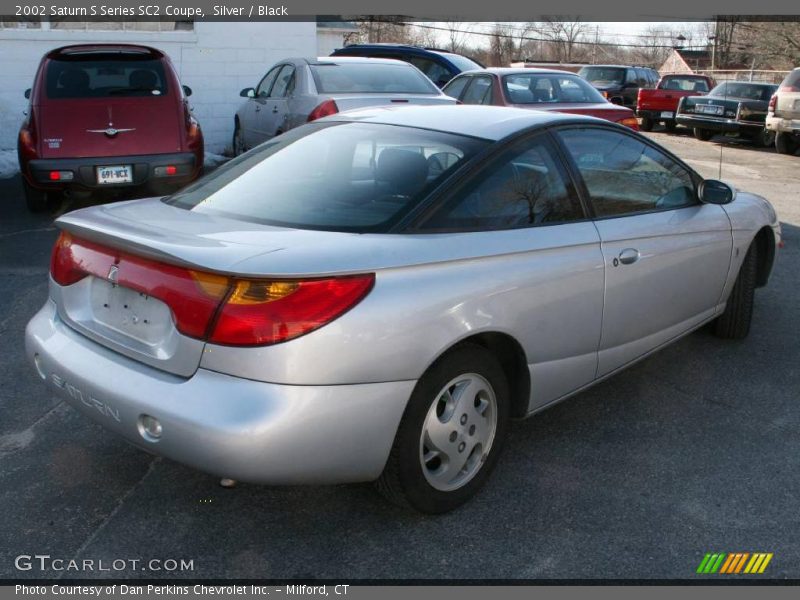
left=331, top=44, right=483, bottom=87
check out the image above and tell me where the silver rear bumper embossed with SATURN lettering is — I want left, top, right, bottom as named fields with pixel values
left=25, top=300, right=416, bottom=484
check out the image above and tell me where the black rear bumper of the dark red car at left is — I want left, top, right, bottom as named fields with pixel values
left=25, top=152, right=202, bottom=190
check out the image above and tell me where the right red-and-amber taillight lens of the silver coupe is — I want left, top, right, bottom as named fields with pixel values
left=209, top=274, right=375, bottom=346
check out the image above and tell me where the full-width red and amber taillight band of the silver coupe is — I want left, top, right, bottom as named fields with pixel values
left=50, top=232, right=375, bottom=346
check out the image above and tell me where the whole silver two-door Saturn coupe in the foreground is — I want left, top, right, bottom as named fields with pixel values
left=27, top=106, right=780, bottom=512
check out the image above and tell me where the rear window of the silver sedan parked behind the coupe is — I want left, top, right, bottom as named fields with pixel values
left=311, top=63, right=439, bottom=94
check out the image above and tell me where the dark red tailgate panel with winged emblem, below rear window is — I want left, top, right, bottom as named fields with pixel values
left=36, top=96, right=183, bottom=158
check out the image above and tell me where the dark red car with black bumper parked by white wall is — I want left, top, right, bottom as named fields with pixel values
left=17, top=44, right=203, bottom=212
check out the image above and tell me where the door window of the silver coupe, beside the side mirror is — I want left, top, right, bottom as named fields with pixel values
left=558, top=128, right=697, bottom=217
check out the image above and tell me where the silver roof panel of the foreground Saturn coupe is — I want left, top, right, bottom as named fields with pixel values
left=325, top=104, right=608, bottom=140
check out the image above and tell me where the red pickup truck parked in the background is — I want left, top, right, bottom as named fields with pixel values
left=636, top=74, right=715, bottom=131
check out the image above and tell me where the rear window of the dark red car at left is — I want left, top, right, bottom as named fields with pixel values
left=45, top=57, right=168, bottom=99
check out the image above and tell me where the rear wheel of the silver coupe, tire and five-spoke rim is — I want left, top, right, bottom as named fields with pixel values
left=376, top=344, right=509, bottom=513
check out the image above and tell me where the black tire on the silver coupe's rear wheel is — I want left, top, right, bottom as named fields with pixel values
left=376, top=343, right=510, bottom=514
